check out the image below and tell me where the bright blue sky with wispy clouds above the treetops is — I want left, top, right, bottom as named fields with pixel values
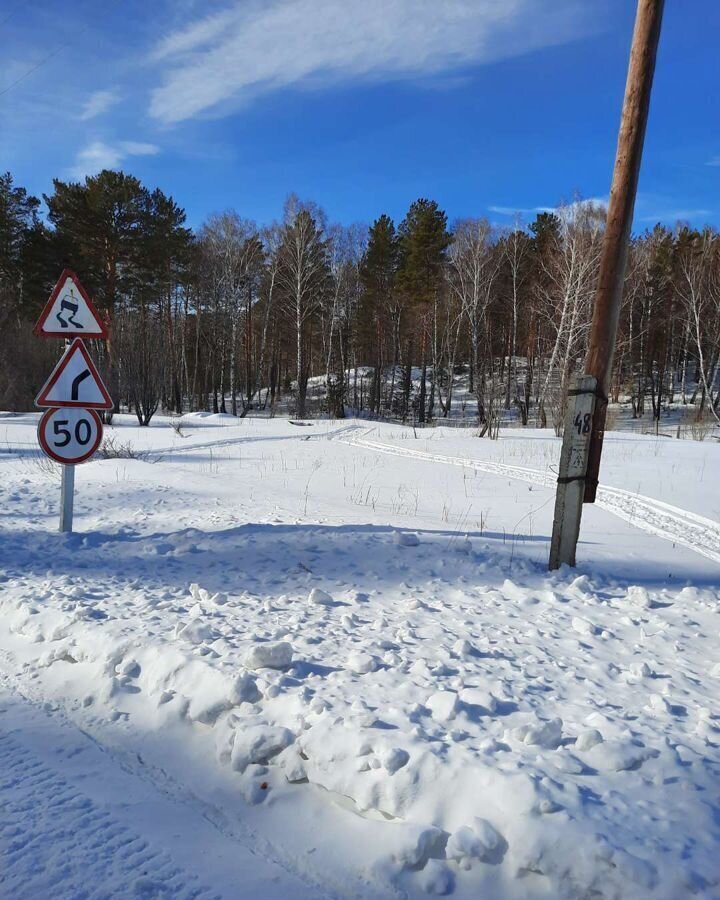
left=0, top=0, right=720, bottom=230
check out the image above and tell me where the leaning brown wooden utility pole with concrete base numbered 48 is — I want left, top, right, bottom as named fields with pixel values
left=550, top=0, right=664, bottom=569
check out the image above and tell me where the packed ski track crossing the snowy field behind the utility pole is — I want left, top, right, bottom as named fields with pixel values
left=342, top=426, right=720, bottom=564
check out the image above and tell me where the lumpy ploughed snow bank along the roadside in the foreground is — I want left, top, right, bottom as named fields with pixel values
left=2, top=556, right=716, bottom=897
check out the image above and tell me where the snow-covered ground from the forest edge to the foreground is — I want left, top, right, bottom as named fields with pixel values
left=0, top=415, right=720, bottom=900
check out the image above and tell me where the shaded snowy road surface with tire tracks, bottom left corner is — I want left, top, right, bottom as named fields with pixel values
left=0, top=668, right=354, bottom=900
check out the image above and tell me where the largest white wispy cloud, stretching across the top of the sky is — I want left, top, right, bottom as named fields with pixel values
left=150, top=0, right=595, bottom=123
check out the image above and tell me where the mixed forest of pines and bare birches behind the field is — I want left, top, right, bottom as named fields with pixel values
left=0, top=170, right=720, bottom=436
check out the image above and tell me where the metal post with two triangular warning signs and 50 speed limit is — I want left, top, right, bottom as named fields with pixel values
left=33, top=269, right=113, bottom=532
